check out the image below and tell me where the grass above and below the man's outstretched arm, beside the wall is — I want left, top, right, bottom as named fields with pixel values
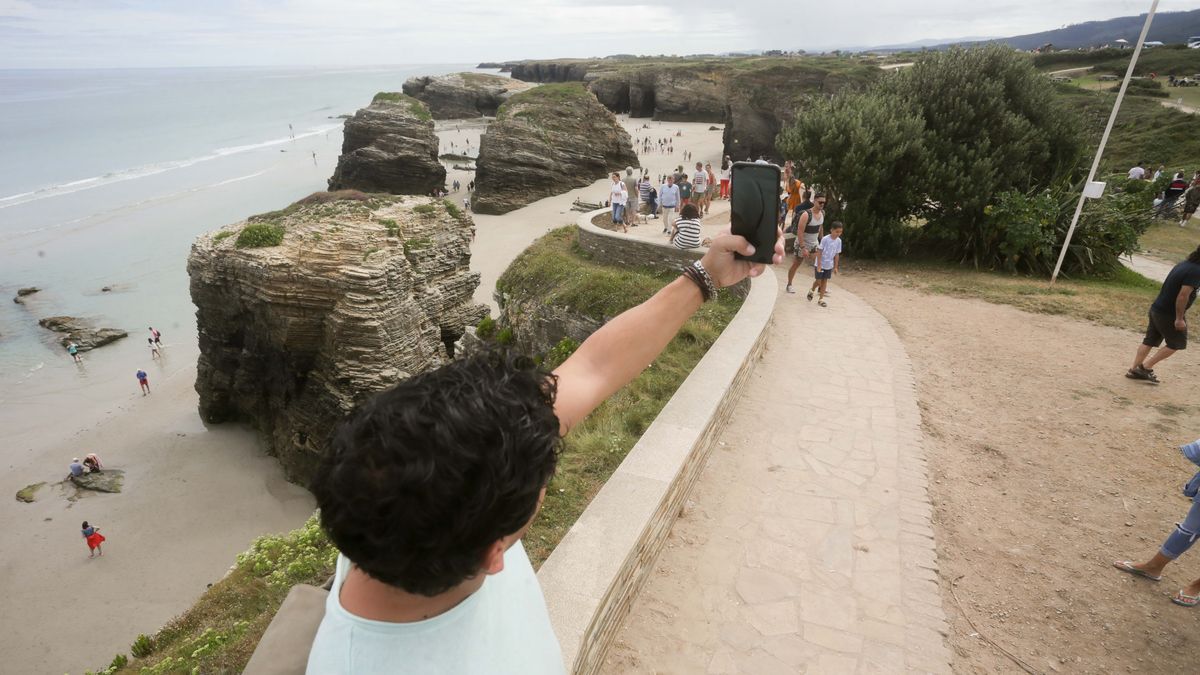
left=497, top=227, right=740, bottom=566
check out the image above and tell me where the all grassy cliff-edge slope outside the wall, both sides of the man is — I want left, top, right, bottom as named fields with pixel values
left=110, top=227, right=740, bottom=674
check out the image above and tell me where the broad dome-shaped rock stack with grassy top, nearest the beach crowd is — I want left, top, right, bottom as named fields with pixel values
left=472, top=83, right=637, bottom=214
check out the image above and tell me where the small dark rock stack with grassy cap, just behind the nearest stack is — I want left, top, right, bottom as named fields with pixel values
left=329, top=92, right=446, bottom=195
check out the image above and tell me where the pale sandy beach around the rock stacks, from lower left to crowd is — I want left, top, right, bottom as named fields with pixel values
left=0, top=117, right=721, bottom=674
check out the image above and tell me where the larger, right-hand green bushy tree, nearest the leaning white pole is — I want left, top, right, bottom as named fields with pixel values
left=902, top=46, right=1082, bottom=265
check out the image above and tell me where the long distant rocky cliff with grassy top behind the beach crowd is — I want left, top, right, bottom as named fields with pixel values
left=512, top=56, right=881, bottom=159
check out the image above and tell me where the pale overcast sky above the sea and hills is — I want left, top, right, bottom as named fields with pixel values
left=0, top=0, right=1200, bottom=68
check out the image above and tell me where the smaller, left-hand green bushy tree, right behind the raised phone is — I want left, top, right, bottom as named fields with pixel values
left=775, top=88, right=925, bottom=256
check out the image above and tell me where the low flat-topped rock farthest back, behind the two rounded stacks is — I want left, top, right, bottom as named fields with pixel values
left=403, top=72, right=534, bottom=120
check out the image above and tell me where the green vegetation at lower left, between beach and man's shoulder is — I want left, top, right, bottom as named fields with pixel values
left=118, top=514, right=337, bottom=674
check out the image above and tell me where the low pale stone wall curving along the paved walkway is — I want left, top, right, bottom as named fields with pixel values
left=538, top=213, right=778, bottom=674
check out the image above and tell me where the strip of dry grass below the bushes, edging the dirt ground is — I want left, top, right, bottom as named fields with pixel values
left=847, top=255, right=1156, bottom=331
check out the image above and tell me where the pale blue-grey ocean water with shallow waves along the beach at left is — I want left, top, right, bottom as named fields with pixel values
left=0, top=65, right=470, bottom=446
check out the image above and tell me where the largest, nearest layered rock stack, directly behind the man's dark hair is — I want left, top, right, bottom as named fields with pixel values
left=187, top=195, right=487, bottom=483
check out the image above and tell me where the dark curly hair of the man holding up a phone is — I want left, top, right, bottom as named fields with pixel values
left=312, top=351, right=562, bottom=596
